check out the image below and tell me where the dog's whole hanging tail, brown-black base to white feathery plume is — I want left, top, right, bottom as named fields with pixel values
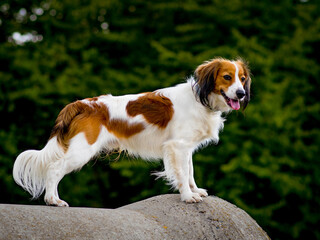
left=13, top=101, right=86, bottom=199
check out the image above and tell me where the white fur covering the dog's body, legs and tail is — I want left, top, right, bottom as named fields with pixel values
left=13, top=78, right=228, bottom=206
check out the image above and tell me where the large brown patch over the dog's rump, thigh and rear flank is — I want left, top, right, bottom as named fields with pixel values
left=50, top=99, right=144, bottom=151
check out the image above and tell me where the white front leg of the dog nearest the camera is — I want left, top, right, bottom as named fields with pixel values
left=163, top=140, right=202, bottom=203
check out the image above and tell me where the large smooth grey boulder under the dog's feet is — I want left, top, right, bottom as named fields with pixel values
left=0, top=194, right=269, bottom=240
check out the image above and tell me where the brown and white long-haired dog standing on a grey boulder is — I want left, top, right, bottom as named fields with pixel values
left=13, top=58, right=251, bottom=206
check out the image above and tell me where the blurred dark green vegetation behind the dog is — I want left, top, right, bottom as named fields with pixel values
left=0, top=0, right=320, bottom=239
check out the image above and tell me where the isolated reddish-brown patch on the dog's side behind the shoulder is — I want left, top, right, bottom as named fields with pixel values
left=126, top=92, right=174, bottom=128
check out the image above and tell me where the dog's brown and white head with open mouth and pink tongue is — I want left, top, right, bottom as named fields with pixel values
left=194, top=58, right=251, bottom=110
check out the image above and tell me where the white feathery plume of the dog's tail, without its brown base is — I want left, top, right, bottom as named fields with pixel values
left=13, top=137, right=64, bottom=199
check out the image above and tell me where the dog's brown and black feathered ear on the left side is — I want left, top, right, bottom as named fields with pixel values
left=193, top=59, right=221, bottom=108
